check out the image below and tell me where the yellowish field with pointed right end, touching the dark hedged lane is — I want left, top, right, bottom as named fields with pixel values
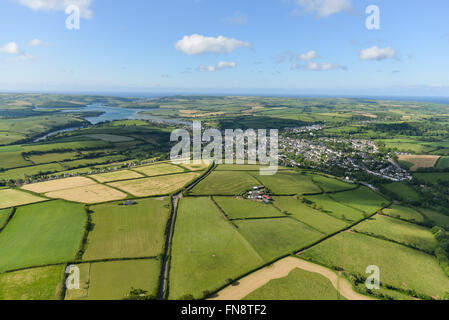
left=108, top=172, right=201, bottom=197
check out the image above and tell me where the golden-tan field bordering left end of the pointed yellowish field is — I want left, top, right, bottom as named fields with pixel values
left=45, top=184, right=126, bottom=203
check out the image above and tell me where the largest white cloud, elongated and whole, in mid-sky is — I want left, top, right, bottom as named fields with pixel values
left=175, top=34, right=251, bottom=55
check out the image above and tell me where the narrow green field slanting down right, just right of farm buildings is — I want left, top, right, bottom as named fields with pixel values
left=274, top=197, right=349, bottom=234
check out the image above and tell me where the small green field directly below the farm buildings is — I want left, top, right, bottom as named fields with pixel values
left=214, top=197, right=283, bottom=219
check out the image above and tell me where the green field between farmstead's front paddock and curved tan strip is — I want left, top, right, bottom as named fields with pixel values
left=235, top=218, right=323, bottom=262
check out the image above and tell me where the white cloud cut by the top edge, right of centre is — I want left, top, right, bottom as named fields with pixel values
left=294, top=0, right=352, bottom=17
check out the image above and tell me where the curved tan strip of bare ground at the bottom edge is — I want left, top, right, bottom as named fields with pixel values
left=211, top=257, right=374, bottom=300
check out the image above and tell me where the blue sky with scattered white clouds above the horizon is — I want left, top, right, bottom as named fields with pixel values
left=0, top=0, right=449, bottom=97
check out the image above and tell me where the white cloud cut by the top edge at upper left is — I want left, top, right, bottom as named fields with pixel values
left=16, top=0, right=93, bottom=19
